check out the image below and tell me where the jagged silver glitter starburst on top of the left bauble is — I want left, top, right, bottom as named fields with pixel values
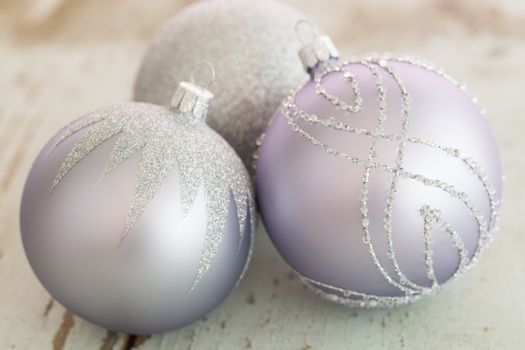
left=48, top=103, right=256, bottom=289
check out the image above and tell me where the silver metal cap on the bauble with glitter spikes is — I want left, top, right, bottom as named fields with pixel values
left=171, top=81, right=213, bottom=121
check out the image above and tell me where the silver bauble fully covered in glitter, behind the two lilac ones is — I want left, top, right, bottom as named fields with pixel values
left=134, top=0, right=307, bottom=171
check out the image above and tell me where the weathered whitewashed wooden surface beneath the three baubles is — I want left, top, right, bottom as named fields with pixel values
left=0, top=0, right=525, bottom=350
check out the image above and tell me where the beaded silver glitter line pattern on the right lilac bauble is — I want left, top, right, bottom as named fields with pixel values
left=274, top=55, right=500, bottom=307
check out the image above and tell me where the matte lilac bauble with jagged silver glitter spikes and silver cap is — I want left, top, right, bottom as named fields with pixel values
left=20, top=83, right=256, bottom=334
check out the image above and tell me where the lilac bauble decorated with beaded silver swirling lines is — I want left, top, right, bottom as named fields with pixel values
left=256, top=36, right=501, bottom=307
